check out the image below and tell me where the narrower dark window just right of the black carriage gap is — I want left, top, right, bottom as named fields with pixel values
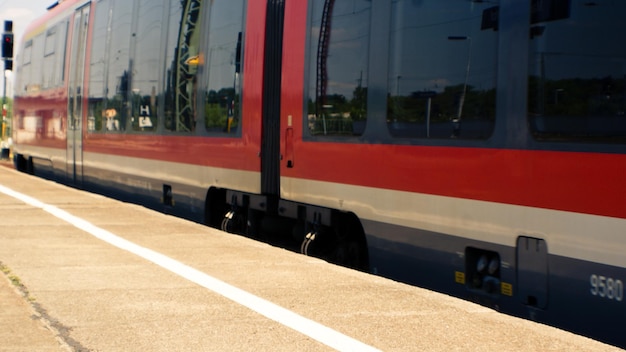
left=307, top=0, right=372, bottom=136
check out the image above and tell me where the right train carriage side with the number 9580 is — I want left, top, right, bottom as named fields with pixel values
left=281, top=0, right=626, bottom=346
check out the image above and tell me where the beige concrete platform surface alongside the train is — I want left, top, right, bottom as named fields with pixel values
left=0, top=168, right=619, bottom=351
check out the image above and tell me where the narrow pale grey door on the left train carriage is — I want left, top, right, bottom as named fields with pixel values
left=66, top=5, right=89, bottom=184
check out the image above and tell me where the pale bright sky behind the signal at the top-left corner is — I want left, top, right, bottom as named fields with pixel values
left=0, top=0, right=56, bottom=96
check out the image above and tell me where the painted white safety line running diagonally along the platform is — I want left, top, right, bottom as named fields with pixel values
left=0, top=185, right=379, bottom=351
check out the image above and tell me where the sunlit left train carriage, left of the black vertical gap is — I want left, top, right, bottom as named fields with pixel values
left=13, top=0, right=265, bottom=221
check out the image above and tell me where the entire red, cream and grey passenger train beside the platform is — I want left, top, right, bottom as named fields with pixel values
left=8, top=0, right=626, bottom=347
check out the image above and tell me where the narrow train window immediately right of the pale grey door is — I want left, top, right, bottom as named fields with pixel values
left=87, top=0, right=112, bottom=131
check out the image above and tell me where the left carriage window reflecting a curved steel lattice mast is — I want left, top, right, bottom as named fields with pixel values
left=164, top=0, right=207, bottom=133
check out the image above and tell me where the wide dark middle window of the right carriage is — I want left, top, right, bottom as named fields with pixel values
left=387, top=0, right=498, bottom=139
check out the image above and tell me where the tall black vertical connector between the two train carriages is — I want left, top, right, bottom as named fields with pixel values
left=261, top=0, right=285, bottom=204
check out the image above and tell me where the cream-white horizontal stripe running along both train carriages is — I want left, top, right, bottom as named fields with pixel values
left=12, top=147, right=626, bottom=267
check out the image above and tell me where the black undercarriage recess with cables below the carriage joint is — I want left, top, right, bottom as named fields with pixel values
left=205, top=188, right=369, bottom=271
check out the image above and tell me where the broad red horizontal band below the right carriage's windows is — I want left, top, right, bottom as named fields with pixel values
left=284, top=143, right=626, bottom=218
